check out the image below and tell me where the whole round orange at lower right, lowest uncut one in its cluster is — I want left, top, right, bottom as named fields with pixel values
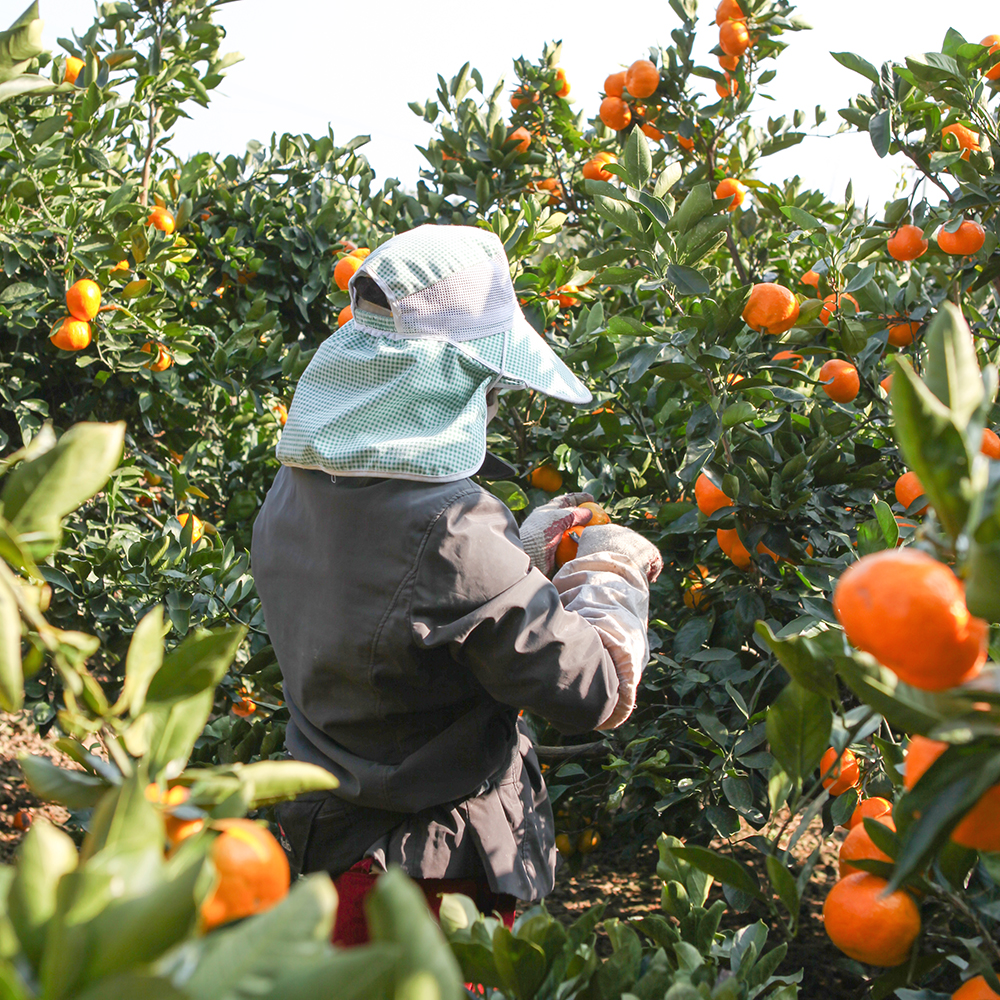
left=823, top=872, right=920, bottom=966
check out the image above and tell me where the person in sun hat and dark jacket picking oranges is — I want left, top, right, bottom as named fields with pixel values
left=252, top=226, right=663, bottom=944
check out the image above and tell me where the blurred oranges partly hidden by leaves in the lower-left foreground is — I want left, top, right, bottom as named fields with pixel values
left=145, top=783, right=291, bottom=932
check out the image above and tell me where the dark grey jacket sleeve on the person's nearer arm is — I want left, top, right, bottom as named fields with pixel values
left=410, top=487, right=619, bottom=733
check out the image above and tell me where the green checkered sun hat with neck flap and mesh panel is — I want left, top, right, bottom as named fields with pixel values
left=278, top=226, right=591, bottom=482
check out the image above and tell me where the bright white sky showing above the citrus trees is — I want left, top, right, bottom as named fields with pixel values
left=37, top=0, right=1000, bottom=209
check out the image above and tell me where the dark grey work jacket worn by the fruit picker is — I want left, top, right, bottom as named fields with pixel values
left=252, top=466, right=618, bottom=900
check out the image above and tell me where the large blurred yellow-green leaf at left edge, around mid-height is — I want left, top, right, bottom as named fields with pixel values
left=0, top=421, right=125, bottom=552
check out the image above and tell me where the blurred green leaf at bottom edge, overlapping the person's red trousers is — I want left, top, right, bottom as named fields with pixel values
left=365, top=868, right=464, bottom=1000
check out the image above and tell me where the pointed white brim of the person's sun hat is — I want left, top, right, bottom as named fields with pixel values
left=453, top=309, right=593, bottom=406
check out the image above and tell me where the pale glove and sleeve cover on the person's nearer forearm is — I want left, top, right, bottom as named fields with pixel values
left=552, top=524, right=663, bottom=729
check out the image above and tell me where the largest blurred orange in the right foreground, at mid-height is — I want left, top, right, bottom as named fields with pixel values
left=833, top=548, right=989, bottom=691
